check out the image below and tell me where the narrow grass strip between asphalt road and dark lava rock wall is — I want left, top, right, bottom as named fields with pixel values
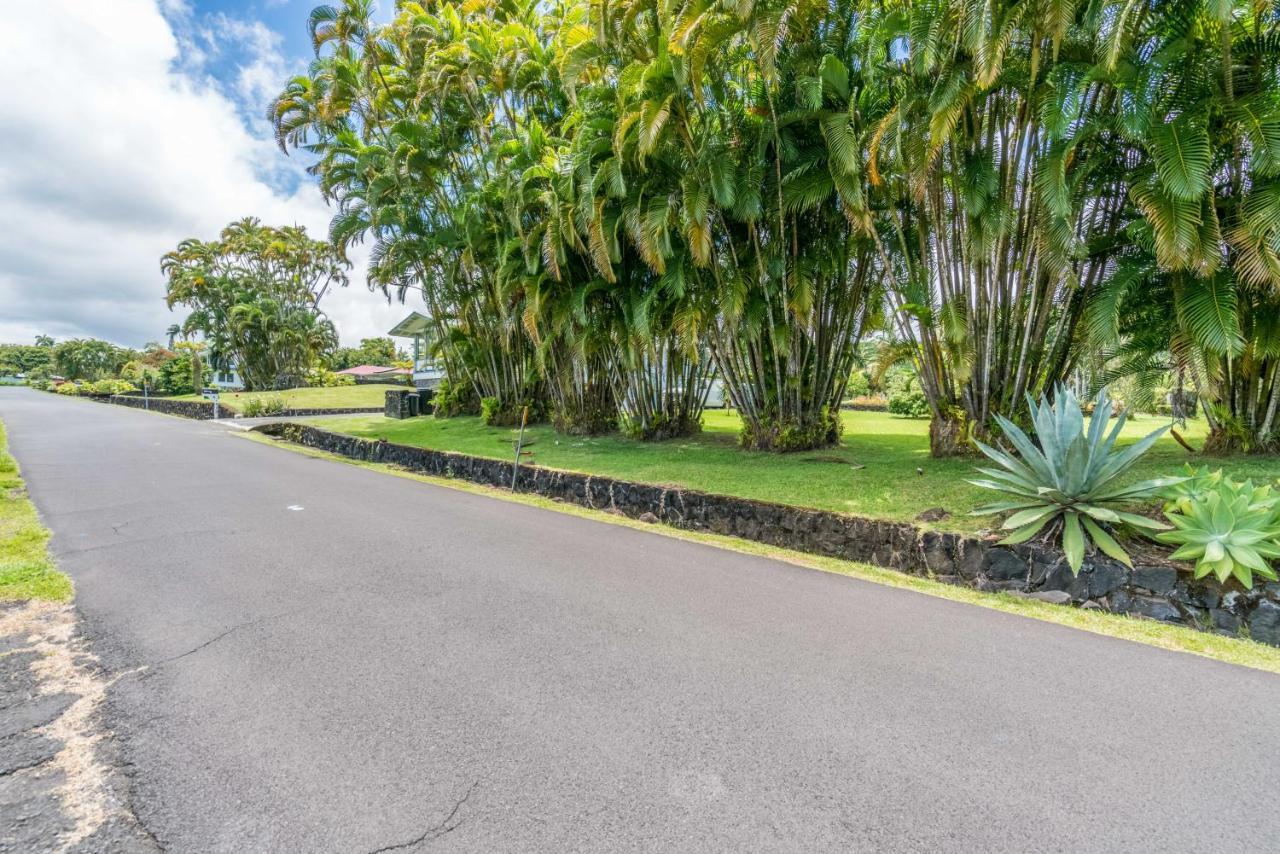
left=234, top=431, right=1280, bottom=673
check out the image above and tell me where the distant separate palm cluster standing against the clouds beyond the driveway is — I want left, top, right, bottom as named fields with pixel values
left=160, top=219, right=351, bottom=391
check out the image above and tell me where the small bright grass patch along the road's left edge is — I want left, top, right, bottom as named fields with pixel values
left=0, top=423, right=72, bottom=602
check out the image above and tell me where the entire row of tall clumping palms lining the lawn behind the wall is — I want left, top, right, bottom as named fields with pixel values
left=270, top=0, right=1280, bottom=455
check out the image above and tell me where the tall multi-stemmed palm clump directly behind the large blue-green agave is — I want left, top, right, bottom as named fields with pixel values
left=864, top=0, right=1126, bottom=455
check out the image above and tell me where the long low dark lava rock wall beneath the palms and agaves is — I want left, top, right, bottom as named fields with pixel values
left=257, top=424, right=1280, bottom=647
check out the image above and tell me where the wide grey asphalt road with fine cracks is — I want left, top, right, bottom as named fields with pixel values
left=0, top=388, right=1280, bottom=851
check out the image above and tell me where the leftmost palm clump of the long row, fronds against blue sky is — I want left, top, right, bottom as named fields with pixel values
left=271, top=0, right=550, bottom=419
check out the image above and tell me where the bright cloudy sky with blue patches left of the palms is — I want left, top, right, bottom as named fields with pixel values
left=0, top=0, right=416, bottom=346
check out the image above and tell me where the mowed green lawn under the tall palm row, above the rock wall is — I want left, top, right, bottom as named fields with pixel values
left=315, top=410, right=1280, bottom=531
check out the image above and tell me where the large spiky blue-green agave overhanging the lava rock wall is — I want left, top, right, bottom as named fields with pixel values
left=969, top=387, right=1181, bottom=574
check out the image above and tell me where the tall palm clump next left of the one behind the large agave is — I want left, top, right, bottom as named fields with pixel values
left=583, top=3, right=878, bottom=449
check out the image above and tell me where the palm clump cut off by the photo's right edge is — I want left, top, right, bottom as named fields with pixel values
left=1094, top=1, right=1280, bottom=452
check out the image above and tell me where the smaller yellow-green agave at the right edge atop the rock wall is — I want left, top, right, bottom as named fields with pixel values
left=1156, top=478, right=1280, bottom=588
